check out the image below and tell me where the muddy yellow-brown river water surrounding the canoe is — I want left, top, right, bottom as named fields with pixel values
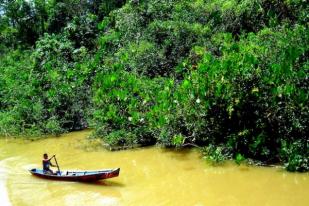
left=0, top=131, right=309, bottom=206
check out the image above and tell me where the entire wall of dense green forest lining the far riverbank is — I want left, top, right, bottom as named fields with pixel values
left=0, top=0, right=309, bottom=171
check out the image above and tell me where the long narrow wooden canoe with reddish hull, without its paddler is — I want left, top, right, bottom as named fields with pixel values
left=29, top=168, right=120, bottom=182
